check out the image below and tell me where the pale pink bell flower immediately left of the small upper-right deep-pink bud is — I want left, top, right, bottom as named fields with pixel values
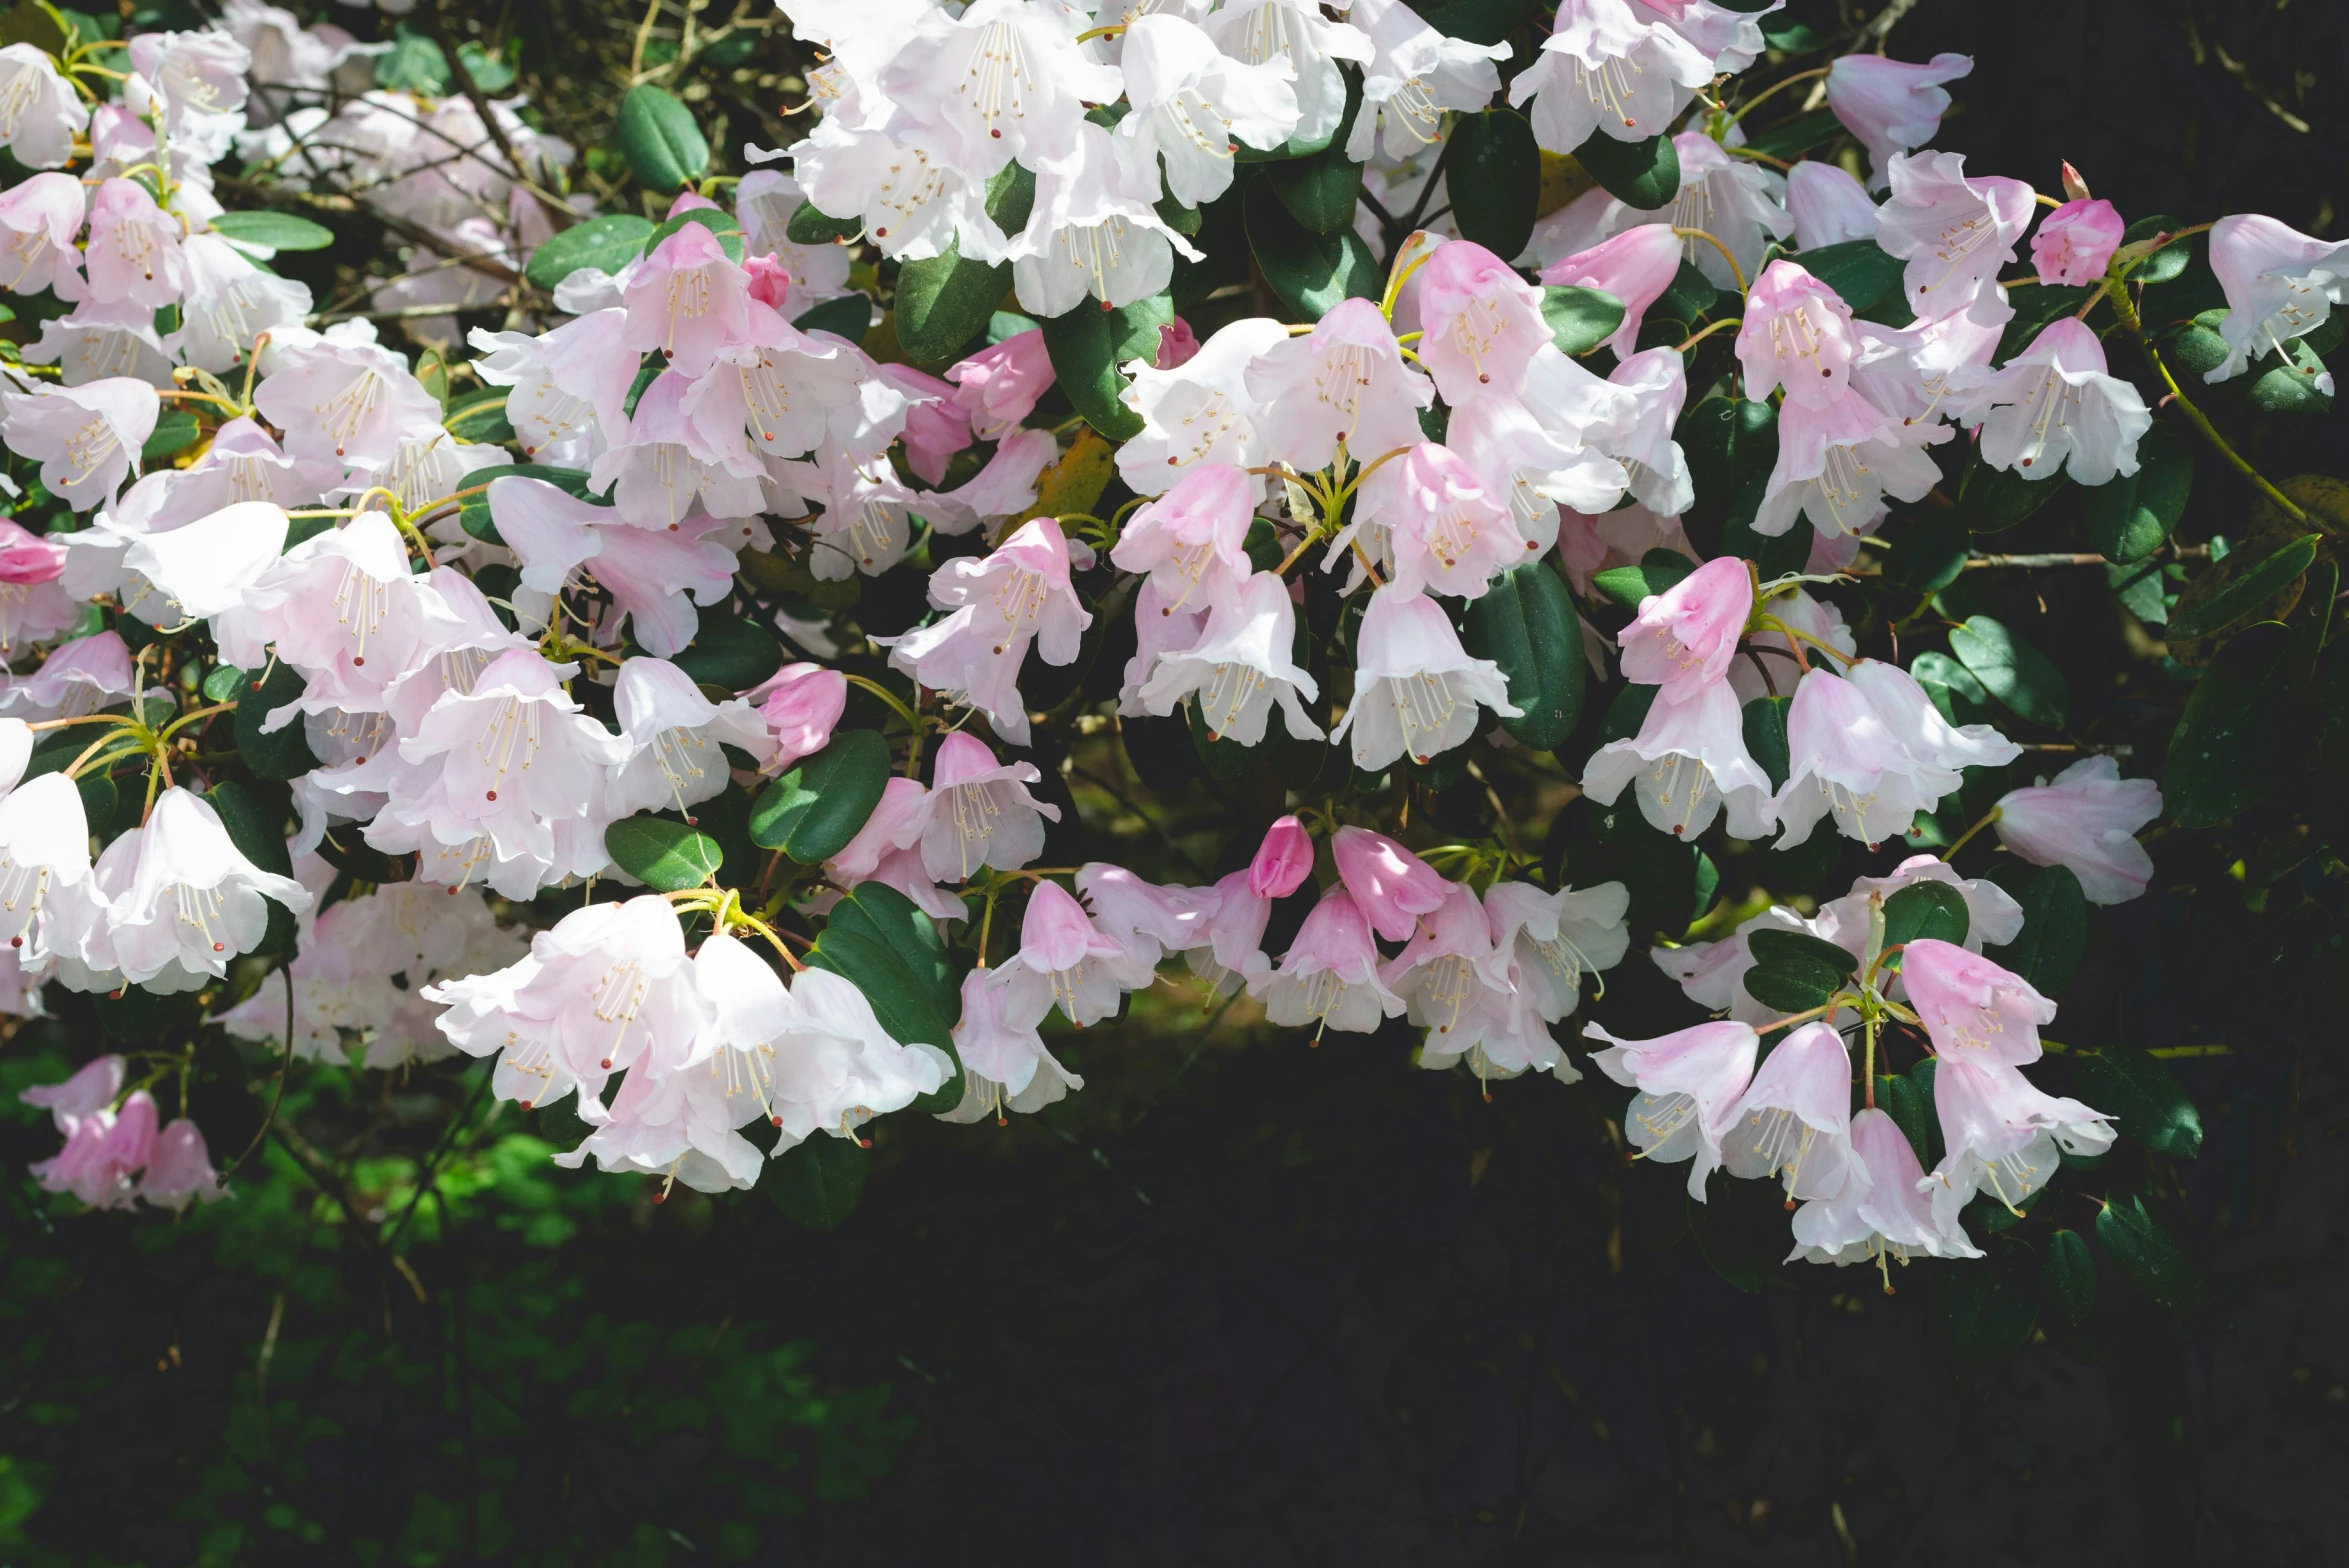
left=1877, top=153, right=2034, bottom=322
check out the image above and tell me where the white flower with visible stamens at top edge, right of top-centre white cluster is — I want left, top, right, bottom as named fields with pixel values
left=1508, top=0, right=1712, bottom=153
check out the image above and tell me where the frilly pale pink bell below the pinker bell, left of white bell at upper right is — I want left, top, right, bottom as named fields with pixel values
left=1752, top=392, right=1950, bottom=540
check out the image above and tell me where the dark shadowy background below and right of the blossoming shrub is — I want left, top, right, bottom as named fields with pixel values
left=0, top=0, right=2349, bottom=1566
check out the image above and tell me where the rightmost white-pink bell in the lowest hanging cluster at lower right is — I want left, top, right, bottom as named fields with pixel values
left=1919, top=1056, right=2112, bottom=1230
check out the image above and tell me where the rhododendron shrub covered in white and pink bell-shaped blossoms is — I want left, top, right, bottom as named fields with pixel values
left=0, top=0, right=2349, bottom=1389
